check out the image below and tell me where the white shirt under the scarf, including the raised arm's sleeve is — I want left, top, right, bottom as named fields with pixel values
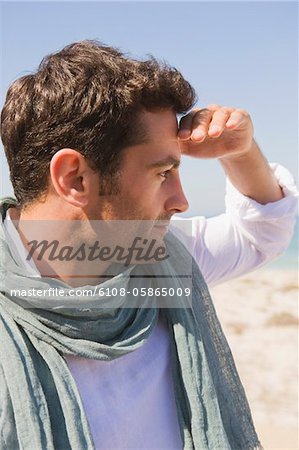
left=0, top=164, right=297, bottom=450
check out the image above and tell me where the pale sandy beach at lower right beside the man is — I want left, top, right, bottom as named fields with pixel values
left=211, top=269, right=299, bottom=450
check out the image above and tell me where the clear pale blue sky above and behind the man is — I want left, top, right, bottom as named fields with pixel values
left=0, top=1, right=298, bottom=216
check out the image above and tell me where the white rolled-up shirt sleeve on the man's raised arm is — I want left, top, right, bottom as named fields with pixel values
left=172, top=164, right=298, bottom=286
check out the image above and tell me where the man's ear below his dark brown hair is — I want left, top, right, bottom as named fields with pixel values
left=50, top=148, right=94, bottom=208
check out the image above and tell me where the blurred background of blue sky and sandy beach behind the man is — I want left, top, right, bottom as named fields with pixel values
left=0, top=1, right=298, bottom=449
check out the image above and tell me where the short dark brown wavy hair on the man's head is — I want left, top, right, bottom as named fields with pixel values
left=1, top=40, right=195, bottom=207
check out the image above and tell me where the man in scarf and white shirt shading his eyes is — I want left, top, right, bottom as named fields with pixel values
left=0, top=41, right=296, bottom=450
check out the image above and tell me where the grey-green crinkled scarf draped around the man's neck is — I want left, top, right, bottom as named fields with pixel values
left=0, top=199, right=262, bottom=450
